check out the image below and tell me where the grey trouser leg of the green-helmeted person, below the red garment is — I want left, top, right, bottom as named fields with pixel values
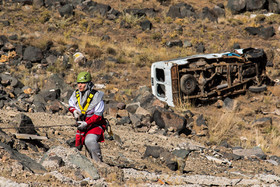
left=85, top=134, right=102, bottom=162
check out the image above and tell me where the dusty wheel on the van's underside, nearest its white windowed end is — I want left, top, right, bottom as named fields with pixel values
left=180, top=74, right=197, bottom=95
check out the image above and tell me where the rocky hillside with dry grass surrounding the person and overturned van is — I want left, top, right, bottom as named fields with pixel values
left=0, top=0, right=280, bottom=186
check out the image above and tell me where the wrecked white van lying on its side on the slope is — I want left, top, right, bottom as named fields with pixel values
left=151, top=48, right=267, bottom=106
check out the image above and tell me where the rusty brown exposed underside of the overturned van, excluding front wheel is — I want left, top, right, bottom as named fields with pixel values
left=174, top=50, right=266, bottom=101
